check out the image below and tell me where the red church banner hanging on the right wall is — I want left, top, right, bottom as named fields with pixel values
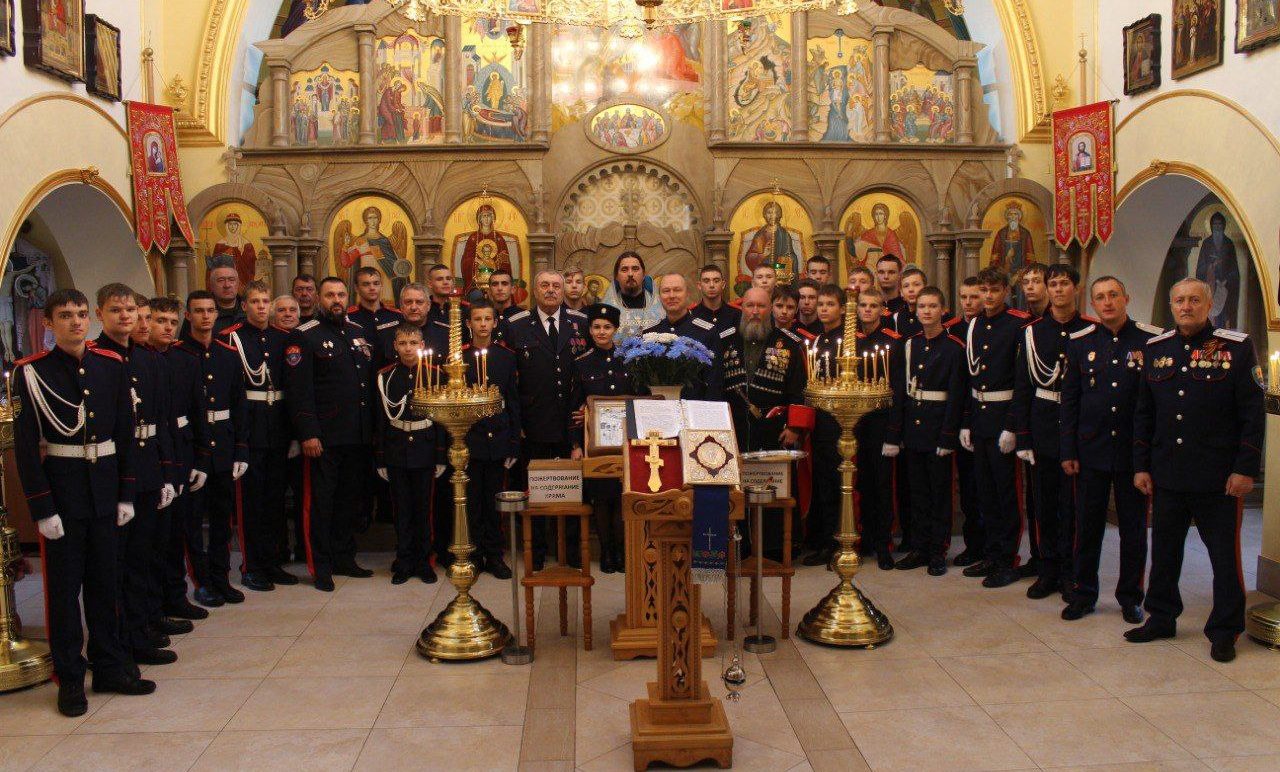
left=1053, top=102, right=1116, bottom=247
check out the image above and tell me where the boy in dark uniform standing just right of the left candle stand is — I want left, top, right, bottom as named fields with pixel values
left=463, top=300, right=517, bottom=579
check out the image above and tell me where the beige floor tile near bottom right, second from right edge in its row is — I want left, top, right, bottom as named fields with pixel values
left=986, top=699, right=1188, bottom=767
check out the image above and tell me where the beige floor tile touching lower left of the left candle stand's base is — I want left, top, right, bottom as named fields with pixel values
left=270, top=634, right=417, bottom=679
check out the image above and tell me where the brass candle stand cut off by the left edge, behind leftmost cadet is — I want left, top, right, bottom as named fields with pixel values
left=0, top=398, right=54, bottom=691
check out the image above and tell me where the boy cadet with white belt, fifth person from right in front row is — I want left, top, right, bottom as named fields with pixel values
left=882, top=287, right=966, bottom=576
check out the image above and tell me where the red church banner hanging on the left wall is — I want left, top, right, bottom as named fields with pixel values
left=125, top=102, right=196, bottom=252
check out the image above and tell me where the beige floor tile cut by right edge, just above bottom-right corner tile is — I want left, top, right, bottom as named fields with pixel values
left=1124, top=691, right=1280, bottom=758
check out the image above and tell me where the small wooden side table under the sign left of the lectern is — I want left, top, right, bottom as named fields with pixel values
left=520, top=504, right=595, bottom=652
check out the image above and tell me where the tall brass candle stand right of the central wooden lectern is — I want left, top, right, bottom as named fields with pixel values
left=796, top=297, right=893, bottom=647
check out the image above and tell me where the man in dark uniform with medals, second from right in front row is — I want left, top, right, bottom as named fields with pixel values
left=1054, top=277, right=1161, bottom=625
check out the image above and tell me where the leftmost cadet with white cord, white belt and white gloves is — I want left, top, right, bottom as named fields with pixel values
left=13, top=289, right=156, bottom=717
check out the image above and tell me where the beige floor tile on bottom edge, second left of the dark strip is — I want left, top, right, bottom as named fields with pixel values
left=192, top=728, right=369, bottom=772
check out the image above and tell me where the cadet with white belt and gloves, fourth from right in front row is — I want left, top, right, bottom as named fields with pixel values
left=960, top=268, right=1028, bottom=588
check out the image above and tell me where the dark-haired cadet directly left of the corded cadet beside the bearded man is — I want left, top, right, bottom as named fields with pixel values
left=178, top=289, right=248, bottom=608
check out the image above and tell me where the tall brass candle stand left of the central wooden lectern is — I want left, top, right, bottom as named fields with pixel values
left=410, top=297, right=511, bottom=661
